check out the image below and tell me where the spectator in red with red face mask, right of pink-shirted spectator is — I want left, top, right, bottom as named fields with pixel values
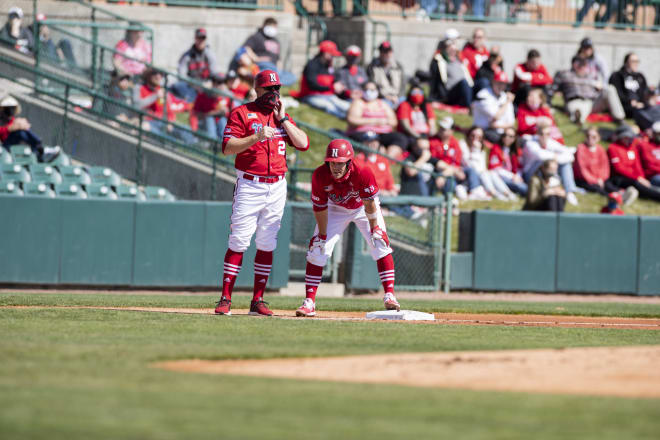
left=396, top=85, right=437, bottom=150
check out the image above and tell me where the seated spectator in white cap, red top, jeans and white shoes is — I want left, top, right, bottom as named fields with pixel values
left=430, top=116, right=489, bottom=200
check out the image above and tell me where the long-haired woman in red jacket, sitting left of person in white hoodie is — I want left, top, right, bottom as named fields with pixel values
left=488, top=128, right=527, bottom=196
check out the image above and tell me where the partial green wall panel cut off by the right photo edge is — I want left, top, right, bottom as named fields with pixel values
left=637, top=217, right=660, bottom=295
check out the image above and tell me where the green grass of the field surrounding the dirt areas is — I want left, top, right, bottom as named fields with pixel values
left=0, top=294, right=660, bottom=440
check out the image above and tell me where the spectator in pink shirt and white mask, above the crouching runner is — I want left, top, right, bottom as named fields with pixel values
left=346, top=81, right=409, bottom=160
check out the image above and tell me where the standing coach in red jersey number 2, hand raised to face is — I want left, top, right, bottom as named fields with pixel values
left=215, top=70, right=309, bottom=316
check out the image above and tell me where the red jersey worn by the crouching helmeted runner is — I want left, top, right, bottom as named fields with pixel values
left=311, top=161, right=378, bottom=211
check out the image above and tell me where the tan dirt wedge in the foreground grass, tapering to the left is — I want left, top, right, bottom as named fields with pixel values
left=152, top=346, right=660, bottom=398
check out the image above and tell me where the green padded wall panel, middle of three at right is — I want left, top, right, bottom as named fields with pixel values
left=557, top=214, right=639, bottom=293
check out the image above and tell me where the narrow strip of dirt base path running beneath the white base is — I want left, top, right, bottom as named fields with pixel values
left=5, top=306, right=660, bottom=330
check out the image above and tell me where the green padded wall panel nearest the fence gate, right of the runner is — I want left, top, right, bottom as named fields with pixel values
left=474, top=211, right=557, bottom=292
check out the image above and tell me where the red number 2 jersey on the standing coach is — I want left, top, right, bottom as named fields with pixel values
left=222, top=102, right=309, bottom=176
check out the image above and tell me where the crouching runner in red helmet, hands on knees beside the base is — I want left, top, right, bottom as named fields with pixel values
left=296, top=139, right=399, bottom=316
